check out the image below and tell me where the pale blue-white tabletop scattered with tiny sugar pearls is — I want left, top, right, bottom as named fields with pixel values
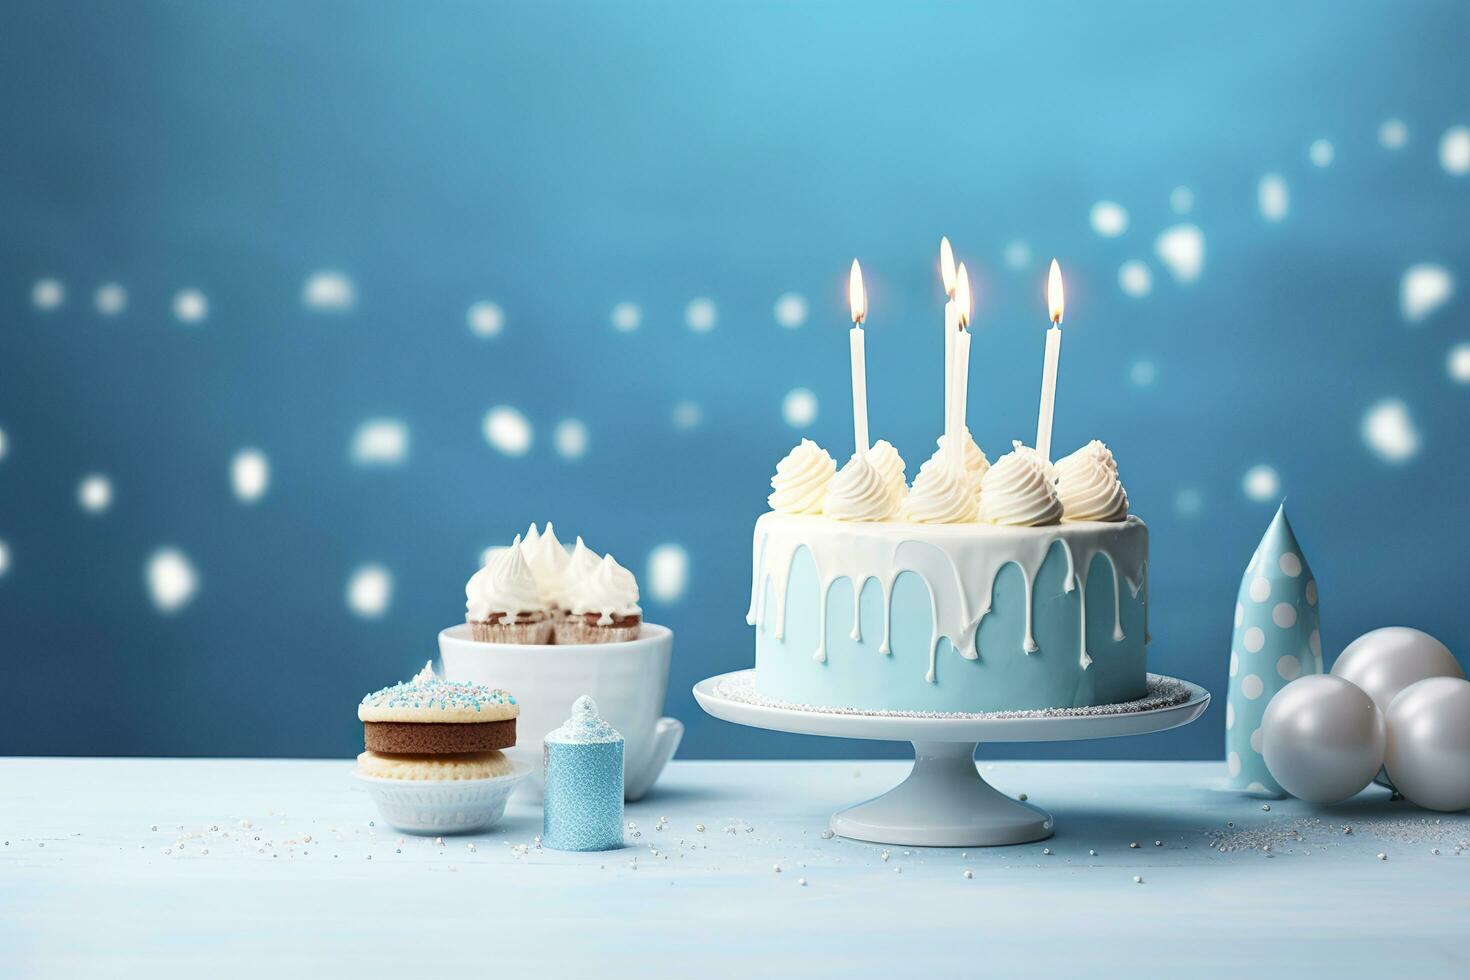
left=0, top=758, right=1470, bottom=979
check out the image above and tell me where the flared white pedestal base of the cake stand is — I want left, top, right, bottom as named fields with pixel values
left=832, top=742, right=1051, bottom=848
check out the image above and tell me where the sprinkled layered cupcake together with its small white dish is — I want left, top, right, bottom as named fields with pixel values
left=356, top=664, right=531, bottom=835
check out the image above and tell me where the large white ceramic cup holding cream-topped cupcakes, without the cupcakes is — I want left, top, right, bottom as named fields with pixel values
left=440, top=623, right=684, bottom=801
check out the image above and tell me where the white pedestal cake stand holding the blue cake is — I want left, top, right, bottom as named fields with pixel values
left=694, top=670, right=1210, bottom=848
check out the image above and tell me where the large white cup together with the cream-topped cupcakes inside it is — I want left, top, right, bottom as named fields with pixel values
left=440, top=523, right=684, bottom=801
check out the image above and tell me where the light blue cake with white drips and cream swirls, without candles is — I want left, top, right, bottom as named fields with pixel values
left=747, top=442, right=1148, bottom=713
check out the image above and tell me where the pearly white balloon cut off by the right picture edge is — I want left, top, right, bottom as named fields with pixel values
left=1385, top=677, right=1470, bottom=811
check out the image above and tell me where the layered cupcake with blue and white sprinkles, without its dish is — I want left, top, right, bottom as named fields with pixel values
left=357, top=664, right=520, bottom=780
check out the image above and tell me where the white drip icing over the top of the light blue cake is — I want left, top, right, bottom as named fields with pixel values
left=745, top=513, right=1148, bottom=683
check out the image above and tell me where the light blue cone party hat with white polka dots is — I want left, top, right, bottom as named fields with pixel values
left=1225, top=504, right=1322, bottom=796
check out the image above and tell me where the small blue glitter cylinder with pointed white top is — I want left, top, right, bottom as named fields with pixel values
left=541, top=695, right=623, bottom=851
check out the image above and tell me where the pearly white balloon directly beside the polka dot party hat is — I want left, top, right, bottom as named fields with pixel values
left=1261, top=674, right=1386, bottom=804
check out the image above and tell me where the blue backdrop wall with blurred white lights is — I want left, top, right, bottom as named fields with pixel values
left=0, top=0, right=1470, bottom=758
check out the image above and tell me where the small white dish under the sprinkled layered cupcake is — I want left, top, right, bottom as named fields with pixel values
left=353, top=763, right=531, bottom=836
